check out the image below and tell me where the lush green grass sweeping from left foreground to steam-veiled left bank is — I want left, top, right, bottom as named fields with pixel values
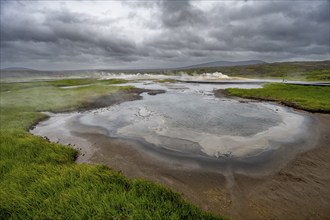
left=0, top=79, right=221, bottom=219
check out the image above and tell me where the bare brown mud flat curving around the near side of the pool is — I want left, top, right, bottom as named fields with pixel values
left=35, top=90, right=330, bottom=219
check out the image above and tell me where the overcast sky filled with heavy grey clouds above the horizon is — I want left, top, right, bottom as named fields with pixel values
left=0, top=0, right=330, bottom=70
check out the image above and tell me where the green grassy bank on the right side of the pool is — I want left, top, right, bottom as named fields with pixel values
left=226, top=83, right=330, bottom=113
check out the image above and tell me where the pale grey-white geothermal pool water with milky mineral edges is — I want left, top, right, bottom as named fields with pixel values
left=33, top=82, right=309, bottom=172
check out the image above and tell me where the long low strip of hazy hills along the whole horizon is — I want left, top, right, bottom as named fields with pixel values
left=0, top=60, right=330, bottom=81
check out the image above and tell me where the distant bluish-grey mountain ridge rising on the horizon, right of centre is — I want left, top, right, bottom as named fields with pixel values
left=180, top=60, right=267, bottom=69
